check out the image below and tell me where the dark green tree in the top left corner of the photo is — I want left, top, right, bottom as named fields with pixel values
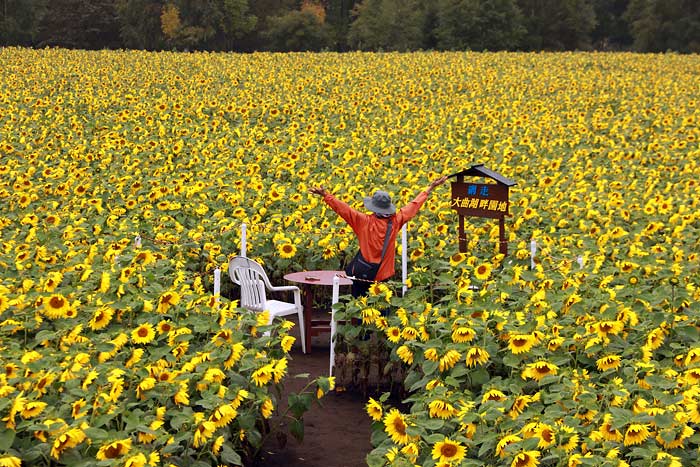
left=0, top=0, right=47, bottom=45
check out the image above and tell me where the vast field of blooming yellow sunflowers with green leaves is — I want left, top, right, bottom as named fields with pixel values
left=0, top=48, right=700, bottom=467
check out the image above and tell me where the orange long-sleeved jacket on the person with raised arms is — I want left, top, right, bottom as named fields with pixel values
left=323, top=191, right=428, bottom=281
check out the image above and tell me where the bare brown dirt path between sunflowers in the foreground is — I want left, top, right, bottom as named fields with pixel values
left=258, top=335, right=372, bottom=467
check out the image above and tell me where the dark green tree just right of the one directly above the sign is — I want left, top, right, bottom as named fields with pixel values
left=518, top=0, right=596, bottom=50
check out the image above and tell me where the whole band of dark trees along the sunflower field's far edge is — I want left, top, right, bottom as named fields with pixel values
left=0, top=0, right=700, bottom=53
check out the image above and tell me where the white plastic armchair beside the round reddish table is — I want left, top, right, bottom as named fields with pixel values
left=228, top=256, right=306, bottom=353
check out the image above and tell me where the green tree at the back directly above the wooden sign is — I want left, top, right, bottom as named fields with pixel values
left=435, top=0, right=525, bottom=50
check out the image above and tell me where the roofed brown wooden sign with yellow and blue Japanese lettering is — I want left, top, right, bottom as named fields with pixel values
left=450, top=164, right=516, bottom=255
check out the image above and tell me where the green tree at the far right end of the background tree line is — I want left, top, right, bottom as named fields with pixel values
left=625, top=0, right=700, bottom=53
